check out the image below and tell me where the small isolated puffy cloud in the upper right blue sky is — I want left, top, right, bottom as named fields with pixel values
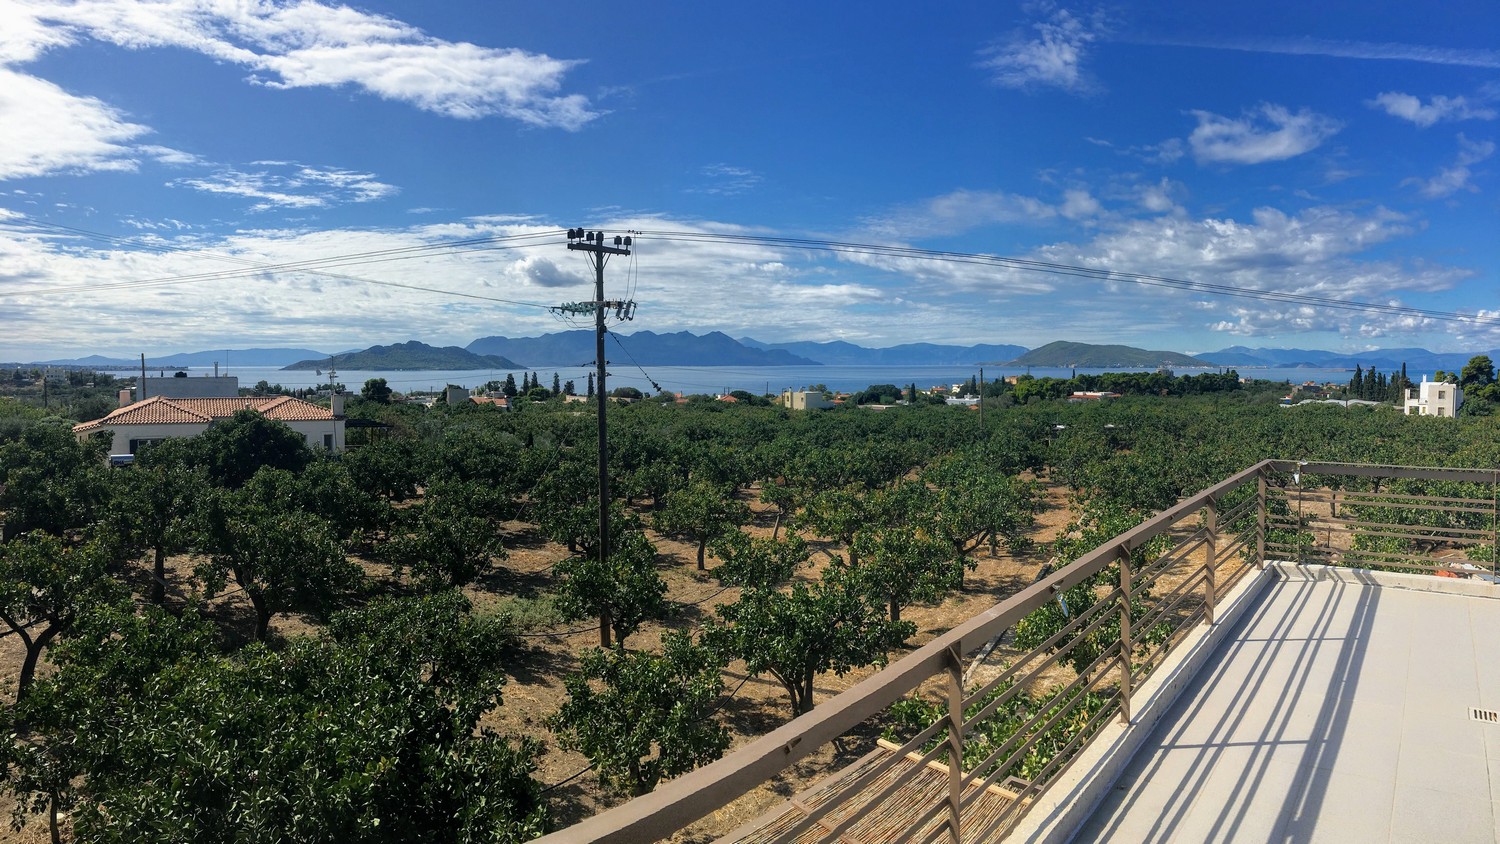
left=1188, top=103, right=1343, bottom=163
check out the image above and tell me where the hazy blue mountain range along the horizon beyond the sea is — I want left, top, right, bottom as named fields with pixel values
left=20, top=335, right=1500, bottom=372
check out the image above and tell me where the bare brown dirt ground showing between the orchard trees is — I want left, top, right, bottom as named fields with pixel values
left=0, top=484, right=1071, bottom=844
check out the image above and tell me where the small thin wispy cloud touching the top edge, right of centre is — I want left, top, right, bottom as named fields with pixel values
left=980, top=3, right=1106, bottom=93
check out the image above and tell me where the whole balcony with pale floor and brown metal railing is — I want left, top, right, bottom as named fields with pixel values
left=543, top=460, right=1500, bottom=843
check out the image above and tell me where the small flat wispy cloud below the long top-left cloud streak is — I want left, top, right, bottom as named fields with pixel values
left=168, top=162, right=398, bottom=211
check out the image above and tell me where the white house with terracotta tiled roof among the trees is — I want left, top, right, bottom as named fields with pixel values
left=74, top=396, right=344, bottom=454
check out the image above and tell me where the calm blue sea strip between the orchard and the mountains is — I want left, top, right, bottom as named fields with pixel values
left=196, top=363, right=1362, bottom=394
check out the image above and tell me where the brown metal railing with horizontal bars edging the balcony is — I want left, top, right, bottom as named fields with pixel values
left=542, top=460, right=1500, bottom=844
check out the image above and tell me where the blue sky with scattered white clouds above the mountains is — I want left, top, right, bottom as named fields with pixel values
left=0, top=0, right=1500, bottom=360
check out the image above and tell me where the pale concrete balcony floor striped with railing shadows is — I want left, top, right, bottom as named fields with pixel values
left=1074, top=580, right=1500, bottom=844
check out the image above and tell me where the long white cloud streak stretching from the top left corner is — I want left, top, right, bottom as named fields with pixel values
left=13, top=0, right=597, bottom=129
